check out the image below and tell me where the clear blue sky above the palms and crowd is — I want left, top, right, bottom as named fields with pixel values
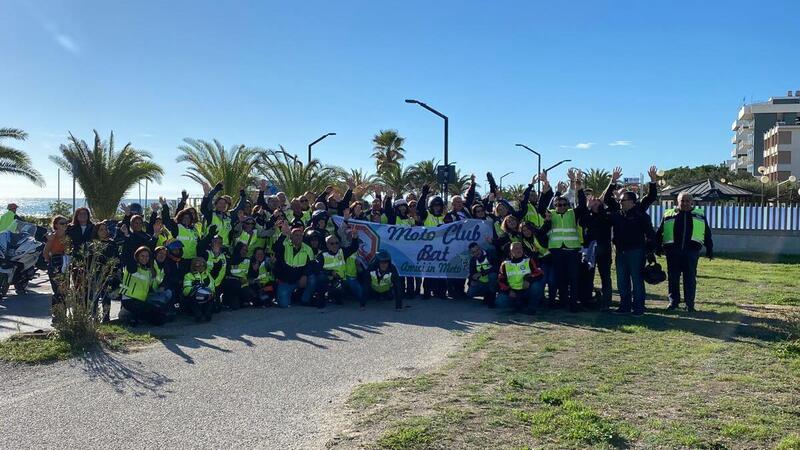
left=0, top=0, right=800, bottom=198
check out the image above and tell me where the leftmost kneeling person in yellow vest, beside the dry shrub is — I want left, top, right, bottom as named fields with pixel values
left=120, top=247, right=171, bottom=325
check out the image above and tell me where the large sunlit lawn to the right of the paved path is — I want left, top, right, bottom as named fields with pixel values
left=329, top=258, right=800, bottom=449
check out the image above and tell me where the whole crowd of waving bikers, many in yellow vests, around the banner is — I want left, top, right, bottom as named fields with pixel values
left=21, top=163, right=713, bottom=324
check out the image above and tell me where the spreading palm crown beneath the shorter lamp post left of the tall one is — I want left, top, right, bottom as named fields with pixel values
left=257, top=147, right=343, bottom=198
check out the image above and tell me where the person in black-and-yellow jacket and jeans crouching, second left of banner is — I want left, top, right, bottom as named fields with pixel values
left=274, top=221, right=316, bottom=308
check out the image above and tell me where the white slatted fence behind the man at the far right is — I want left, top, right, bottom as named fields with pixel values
left=648, top=205, right=800, bottom=231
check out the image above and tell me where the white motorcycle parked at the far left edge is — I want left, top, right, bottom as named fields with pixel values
left=0, top=222, right=44, bottom=299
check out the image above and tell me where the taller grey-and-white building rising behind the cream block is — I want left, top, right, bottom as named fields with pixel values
left=729, top=91, right=800, bottom=176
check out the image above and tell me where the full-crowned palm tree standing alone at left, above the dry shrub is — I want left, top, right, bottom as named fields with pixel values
left=50, top=130, right=164, bottom=219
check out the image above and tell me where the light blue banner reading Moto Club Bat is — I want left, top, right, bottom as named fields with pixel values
left=333, top=216, right=492, bottom=278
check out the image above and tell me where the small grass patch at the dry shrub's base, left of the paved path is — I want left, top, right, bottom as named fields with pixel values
left=0, top=324, right=156, bottom=364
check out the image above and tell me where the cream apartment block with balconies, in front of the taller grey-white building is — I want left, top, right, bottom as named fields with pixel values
left=763, top=122, right=800, bottom=181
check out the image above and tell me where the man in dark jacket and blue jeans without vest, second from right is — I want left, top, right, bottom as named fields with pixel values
left=603, top=167, right=655, bottom=316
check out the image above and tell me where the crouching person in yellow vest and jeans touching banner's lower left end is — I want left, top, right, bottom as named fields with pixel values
left=317, top=229, right=364, bottom=306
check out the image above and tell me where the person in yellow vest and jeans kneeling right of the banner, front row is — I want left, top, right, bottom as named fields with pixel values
left=497, top=242, right=544, bottom=314
